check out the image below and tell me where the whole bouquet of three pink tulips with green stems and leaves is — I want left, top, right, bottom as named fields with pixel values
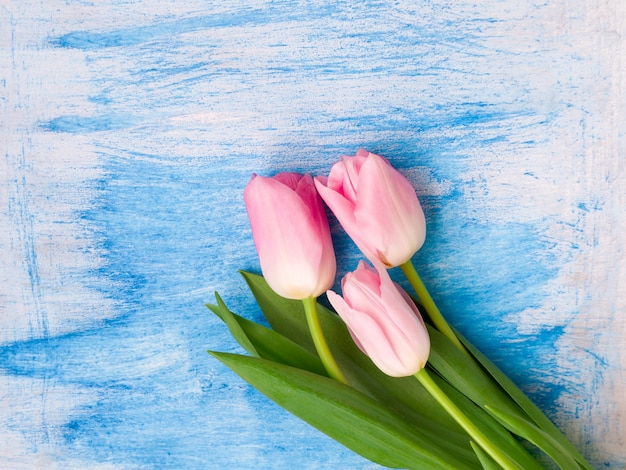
left=207, top=150, right=592, bottom=470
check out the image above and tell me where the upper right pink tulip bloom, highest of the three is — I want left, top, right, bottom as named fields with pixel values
left=315, top=149, right=426, bottom=267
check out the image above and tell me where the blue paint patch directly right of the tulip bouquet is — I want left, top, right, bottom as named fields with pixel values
left=408, top=215, right=565, bottom=411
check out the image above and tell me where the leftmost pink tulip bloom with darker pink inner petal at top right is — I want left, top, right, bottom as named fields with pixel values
left=244, top=173, right=336, bottom=299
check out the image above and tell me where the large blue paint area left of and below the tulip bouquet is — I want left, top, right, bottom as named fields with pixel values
left=0, top=151, right=376, bottom=469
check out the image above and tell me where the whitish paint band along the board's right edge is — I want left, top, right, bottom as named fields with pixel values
left=454, top=1, right=626, bottom=461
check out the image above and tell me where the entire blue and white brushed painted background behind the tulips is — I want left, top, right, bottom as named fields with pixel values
left=0, top=0, right=626, bottom=469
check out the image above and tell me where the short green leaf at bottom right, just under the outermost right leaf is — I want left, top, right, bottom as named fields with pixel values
left=487, top=406, right=580, bottom=470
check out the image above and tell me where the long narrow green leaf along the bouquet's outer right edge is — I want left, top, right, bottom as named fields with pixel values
left=455, top=330, right=593, bottom=470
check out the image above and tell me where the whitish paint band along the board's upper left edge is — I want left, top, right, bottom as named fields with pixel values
left=0, top=1, right=113, bottom=344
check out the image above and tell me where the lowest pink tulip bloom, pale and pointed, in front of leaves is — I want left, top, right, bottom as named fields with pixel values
left=326, top=261, right=430, bottom=377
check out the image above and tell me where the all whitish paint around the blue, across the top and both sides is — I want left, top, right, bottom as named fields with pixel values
left=0, top=0, right=626, bottom=469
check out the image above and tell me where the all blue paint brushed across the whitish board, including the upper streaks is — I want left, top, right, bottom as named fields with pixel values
left=0, top=2, right=608, bottom=469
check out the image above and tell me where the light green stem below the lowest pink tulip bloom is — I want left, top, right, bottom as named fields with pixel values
left=415, top=369, right=520, bottom=470
